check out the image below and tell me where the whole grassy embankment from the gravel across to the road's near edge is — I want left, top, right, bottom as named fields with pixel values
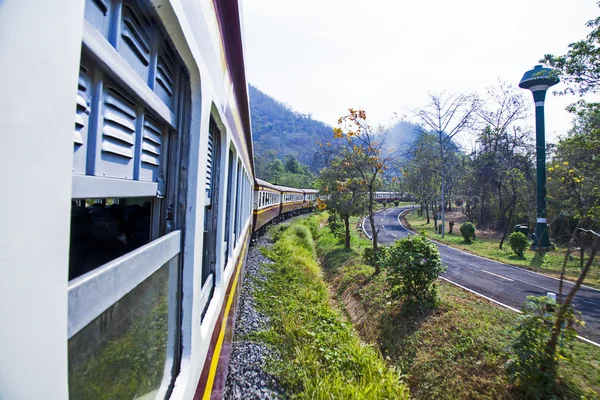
left=261, top=216, right=600, bottom=399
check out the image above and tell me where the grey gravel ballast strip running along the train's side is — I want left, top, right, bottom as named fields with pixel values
left=225, top=236, right=285, bottom=399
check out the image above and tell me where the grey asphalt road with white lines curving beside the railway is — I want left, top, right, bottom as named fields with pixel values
left=363, top=207, right=600, bottom=343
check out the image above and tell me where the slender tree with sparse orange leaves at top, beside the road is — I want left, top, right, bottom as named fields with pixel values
left=328, top=108, right=394, bottom=274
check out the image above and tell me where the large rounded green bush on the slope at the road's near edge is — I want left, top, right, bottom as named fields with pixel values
left=384, top=235, right=445, bottom=305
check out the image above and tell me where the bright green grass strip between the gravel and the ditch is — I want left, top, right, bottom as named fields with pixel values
left=253, top=214, right=408, bottom=399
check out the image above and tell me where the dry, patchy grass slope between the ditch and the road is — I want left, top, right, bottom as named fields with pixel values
left=316, top=217, right=600, bottom=399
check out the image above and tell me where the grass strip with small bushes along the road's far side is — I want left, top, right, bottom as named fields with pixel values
left=405, top=212, right=600, bottom=288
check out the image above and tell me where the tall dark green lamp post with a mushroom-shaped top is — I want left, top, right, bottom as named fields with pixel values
left=519, top=65, right=559, bottom=250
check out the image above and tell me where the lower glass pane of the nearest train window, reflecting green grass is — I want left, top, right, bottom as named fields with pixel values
left=69, top=256, right=179, bottom=400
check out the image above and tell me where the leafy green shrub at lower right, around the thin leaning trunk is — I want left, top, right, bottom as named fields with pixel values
left=508, top=296, right=580, bottom=399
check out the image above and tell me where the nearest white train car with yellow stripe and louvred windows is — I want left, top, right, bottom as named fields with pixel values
left=0, top=0, right=254, bottom=399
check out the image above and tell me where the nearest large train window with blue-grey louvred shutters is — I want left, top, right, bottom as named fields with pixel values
left=68, top=0, right=189, bottom=399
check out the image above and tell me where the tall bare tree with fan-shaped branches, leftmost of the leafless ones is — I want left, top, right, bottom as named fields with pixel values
left=415, top=93, right=478, bottom=237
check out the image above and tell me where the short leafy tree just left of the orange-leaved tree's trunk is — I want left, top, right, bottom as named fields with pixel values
left=317, top=158, right=367, bottom=249
